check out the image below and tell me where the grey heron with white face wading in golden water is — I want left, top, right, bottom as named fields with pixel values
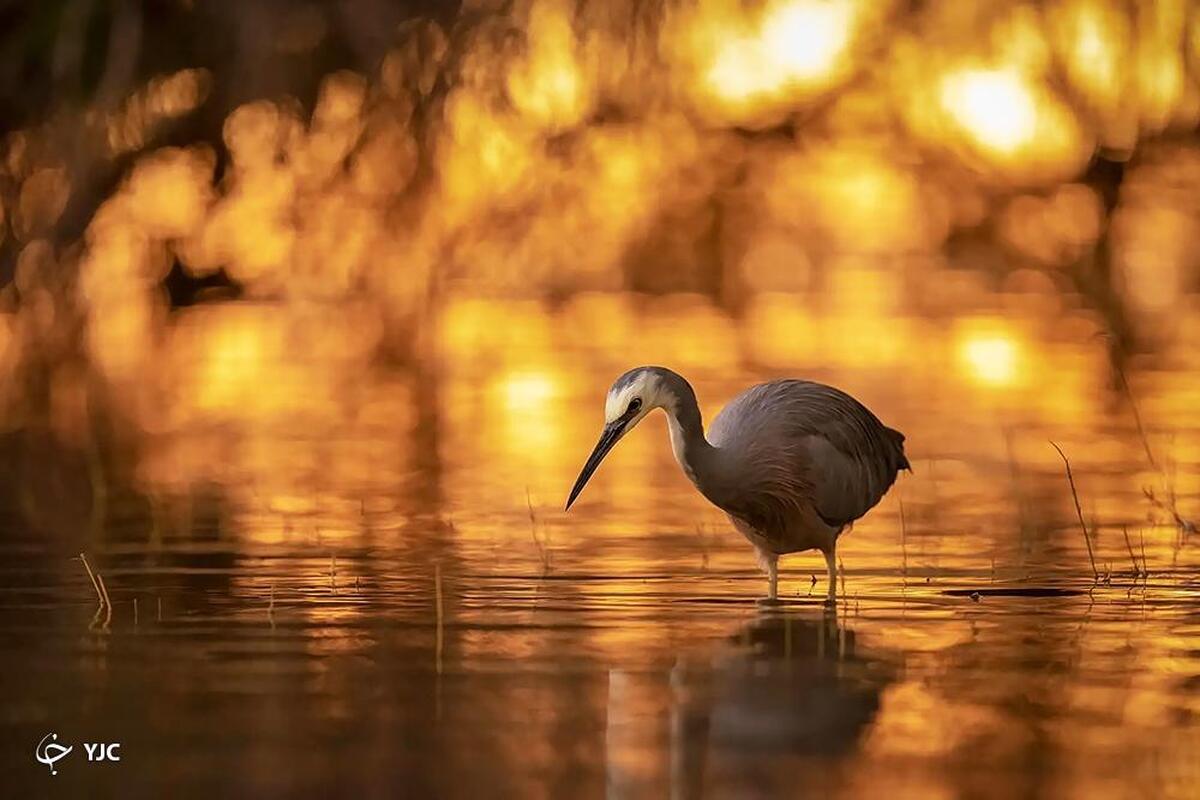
left=566, top=367, right=911, bottom=606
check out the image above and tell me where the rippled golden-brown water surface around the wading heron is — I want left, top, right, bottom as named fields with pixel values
left=0, top=302, right=1200, bottom=798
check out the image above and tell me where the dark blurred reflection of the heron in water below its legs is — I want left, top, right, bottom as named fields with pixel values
left=606, top=613, right=895, bottom=798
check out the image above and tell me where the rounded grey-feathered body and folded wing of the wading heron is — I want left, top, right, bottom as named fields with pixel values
left=709, top=380, right=908, bottom=530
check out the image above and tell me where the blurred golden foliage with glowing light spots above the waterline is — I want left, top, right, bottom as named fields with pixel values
left=0, top=0, right=1200, bottom=441
